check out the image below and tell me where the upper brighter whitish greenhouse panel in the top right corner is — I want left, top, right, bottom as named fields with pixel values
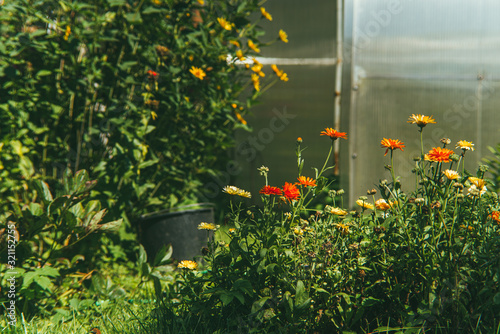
left=352, top=0, right=500, bottom=80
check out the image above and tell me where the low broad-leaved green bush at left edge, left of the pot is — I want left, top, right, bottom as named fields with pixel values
left=0, top=164, right=122, bottom=318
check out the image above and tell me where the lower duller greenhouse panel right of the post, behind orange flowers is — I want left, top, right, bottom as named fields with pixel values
left=350, top=79, right=500, bottom=204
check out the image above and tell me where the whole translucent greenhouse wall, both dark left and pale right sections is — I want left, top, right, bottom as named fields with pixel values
left=230, top=0, right=500, bottom=204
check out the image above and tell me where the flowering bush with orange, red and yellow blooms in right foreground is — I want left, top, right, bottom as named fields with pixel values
left=160, top=115, right=500, bottom=333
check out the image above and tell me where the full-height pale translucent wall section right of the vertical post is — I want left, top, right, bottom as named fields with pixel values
left=343, top=0, right=500, bottom=203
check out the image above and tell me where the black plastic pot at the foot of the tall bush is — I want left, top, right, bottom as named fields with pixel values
left=139, top=205, right=214, bottom=260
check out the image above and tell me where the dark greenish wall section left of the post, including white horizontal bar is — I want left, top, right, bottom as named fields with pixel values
left=233, top=0, right=338, bottom=198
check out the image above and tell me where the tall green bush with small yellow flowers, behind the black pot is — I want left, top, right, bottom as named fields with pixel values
left=0, top=0, right=288, bottom=222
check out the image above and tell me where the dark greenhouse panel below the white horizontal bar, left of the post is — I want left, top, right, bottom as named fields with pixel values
left=233, top=66, right=340, bottom=198
